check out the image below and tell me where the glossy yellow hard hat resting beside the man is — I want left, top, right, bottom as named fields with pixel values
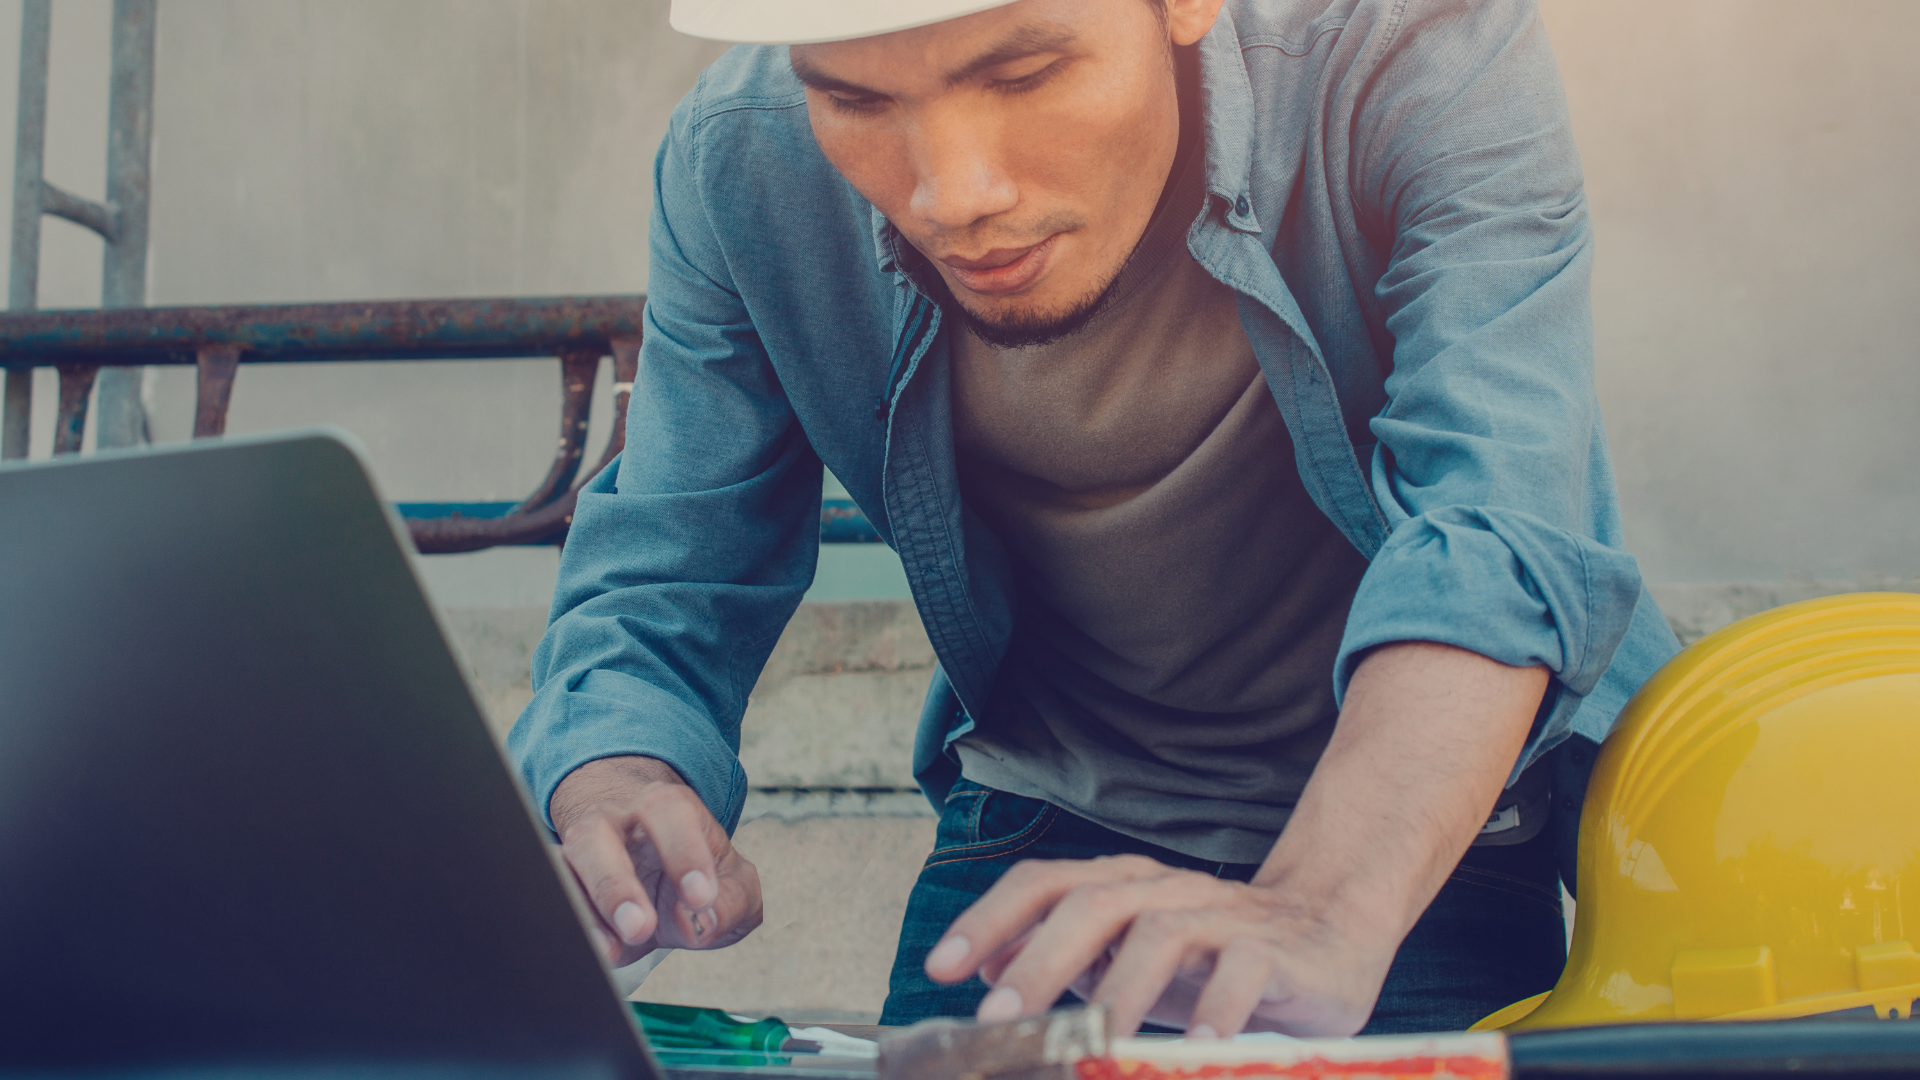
left=1475, top=592, right=1920, bottom=1028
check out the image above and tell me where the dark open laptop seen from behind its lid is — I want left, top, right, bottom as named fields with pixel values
left=0, top=430, right=683, bottom=1080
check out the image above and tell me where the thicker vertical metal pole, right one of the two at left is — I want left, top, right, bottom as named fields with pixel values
left=96, top=0, right=154, bottom=448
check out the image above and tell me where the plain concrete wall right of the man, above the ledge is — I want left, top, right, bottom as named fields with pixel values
left=1544, top=0, right=1920, bottom=582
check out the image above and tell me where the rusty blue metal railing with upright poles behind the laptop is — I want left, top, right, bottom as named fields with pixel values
left=0, top=0, right=879, bottom=553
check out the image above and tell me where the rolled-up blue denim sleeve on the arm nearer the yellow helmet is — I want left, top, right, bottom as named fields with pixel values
left=1334, top=0, right=1644, bottom=767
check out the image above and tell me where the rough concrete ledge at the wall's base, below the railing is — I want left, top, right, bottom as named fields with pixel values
left=445, top=580, right=1920, bottom=1022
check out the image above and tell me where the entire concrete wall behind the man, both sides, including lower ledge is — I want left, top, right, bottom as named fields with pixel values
left=0, top=0, right=1920, bottom=1019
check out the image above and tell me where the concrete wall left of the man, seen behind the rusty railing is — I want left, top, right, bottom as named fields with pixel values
left=0, top=0, right=921, bottom=605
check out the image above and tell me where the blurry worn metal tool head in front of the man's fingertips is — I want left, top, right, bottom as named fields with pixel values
left=879, top=1005, right=1106, bottom=1080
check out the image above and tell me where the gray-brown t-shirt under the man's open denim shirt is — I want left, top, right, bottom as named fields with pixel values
left=952, top=145, right=1367, bottom=863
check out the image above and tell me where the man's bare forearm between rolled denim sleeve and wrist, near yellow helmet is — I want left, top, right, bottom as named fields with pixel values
left=1254, top=642, right=1548, bottom=945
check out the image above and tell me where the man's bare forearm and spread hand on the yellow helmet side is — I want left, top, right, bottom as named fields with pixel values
left=927, top=642, right=1548, bottom=1038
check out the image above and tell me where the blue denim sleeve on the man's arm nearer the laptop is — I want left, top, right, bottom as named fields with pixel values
left=507, top=94, right=822, bottom=830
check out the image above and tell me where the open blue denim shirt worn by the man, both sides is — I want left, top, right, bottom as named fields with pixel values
left=509, top=0, right=1678, bottom=828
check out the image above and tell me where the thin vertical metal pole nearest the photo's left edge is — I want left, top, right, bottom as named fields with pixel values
left=0, top=0, right=54, bottom=461
